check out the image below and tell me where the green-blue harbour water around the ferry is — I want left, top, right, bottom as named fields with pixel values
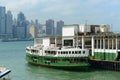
left=0, top=41, right=120, bottom=80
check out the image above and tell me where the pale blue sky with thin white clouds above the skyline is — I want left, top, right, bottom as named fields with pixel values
left=0, top=0, right=120, bottom=32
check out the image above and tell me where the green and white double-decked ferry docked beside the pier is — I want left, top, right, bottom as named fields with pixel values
left=26, top=37, right=89, bottom=71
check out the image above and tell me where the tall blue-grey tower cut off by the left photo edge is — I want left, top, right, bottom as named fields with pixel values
left=0, top=6, right=6, bottom=35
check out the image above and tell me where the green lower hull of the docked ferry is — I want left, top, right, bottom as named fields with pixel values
left=26, top=54, right=89, bottom=71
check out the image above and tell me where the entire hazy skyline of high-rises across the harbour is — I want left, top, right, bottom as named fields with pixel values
left=0, top=6, right=64, bottom=40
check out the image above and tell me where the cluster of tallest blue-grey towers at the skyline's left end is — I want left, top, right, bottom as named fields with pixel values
left=0, top=6, right=29, bottom=39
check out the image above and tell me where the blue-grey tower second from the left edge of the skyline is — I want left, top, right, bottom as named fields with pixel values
left=5, top=11, right=13, bottom=38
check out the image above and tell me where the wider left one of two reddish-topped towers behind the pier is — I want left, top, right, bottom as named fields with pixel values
left=46, top=19, right=55, bottom=35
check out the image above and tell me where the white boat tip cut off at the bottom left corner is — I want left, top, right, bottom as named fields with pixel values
left=0, top=66, right=11, bottom=80
